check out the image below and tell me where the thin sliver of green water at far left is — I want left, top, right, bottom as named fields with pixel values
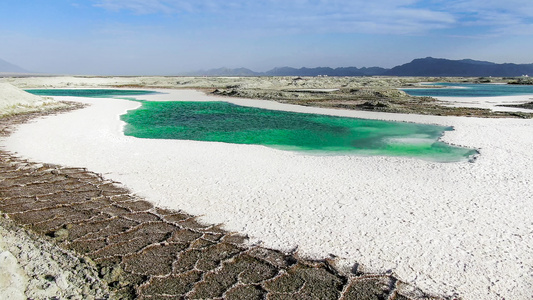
left=26, top=89, right=156, bottom=98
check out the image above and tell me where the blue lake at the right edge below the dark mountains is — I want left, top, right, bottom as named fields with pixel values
left=402, top=83, right=533, bottom=97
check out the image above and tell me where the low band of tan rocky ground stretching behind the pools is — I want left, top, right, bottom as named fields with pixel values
left=4, top=76, right=533, bottom=118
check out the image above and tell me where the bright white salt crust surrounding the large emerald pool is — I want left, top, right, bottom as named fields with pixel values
left=1, top=90, right=533, bottom=299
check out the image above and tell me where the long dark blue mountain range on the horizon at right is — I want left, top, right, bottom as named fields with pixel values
left=187, top=57, right=533, bottom=77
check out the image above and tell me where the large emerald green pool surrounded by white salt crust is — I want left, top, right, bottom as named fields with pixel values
left=121, top=102, right=477, bottom=162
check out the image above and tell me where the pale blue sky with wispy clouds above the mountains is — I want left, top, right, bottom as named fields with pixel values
left=0, top=0, right=533, bottom=75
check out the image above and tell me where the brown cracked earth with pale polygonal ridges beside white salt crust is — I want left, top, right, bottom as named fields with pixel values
left=0, top=108, right=443, bottom=300
